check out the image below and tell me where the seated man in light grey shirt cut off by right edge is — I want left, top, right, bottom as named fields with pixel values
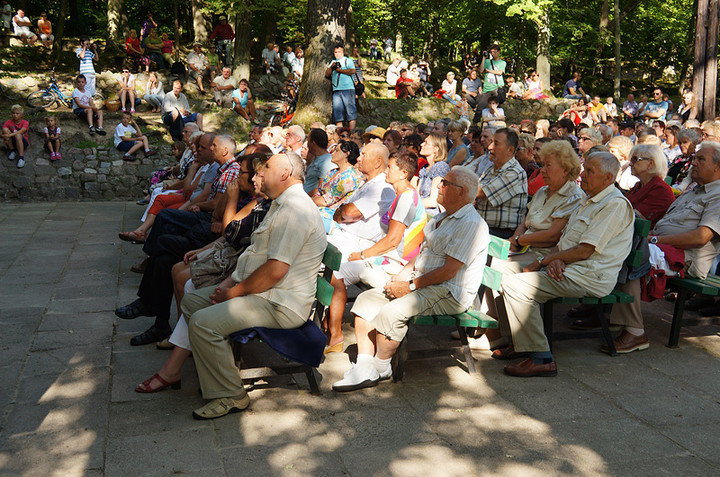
left=603, top=141, right=720, bottom=346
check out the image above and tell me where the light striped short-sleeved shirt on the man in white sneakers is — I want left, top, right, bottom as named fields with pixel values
left=415, top=204, right=490, bottom=308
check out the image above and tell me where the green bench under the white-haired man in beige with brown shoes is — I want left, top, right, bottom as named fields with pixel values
left=542, top=219, right=650, bottom=356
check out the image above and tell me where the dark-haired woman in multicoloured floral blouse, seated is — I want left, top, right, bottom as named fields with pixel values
left=312, top=140, right=363, bottom=232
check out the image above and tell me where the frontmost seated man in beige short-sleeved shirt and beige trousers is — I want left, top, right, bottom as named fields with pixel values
left=182, top=153, right=327, bottom=419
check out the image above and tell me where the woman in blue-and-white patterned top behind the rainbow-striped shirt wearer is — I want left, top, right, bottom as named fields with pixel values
left=412, top=133, right=450, bottom=215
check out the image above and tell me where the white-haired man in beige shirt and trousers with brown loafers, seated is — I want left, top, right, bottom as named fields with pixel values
left=493, top=152, right=635, bottom=377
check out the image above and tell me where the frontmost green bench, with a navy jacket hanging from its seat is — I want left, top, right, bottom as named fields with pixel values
left=233, top=244, right=342, bottom=394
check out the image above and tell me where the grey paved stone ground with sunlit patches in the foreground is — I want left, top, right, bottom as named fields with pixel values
left=0, top=202, right=720, bottom=476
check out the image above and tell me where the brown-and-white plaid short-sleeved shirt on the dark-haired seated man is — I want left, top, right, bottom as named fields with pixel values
left=475, top=157, right=527, bottom=230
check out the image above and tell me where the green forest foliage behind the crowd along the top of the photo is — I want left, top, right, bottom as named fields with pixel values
left=5, top=0, right=696, bottom=95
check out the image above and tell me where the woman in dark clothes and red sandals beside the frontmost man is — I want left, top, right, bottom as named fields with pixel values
left=135, top=154, right=271, bottom=393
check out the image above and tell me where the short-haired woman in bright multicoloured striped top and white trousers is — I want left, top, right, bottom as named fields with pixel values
left=324, top=151, right=426, bottom=353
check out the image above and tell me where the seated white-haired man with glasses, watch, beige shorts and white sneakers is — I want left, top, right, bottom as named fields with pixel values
left=333, top=166, right=490, bottom=392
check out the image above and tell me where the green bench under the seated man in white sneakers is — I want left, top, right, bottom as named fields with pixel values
left=392, top=235, right=510, bottom=382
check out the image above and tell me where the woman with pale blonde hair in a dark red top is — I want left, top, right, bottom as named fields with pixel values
left=625, top=144, right=675, bottom=227
